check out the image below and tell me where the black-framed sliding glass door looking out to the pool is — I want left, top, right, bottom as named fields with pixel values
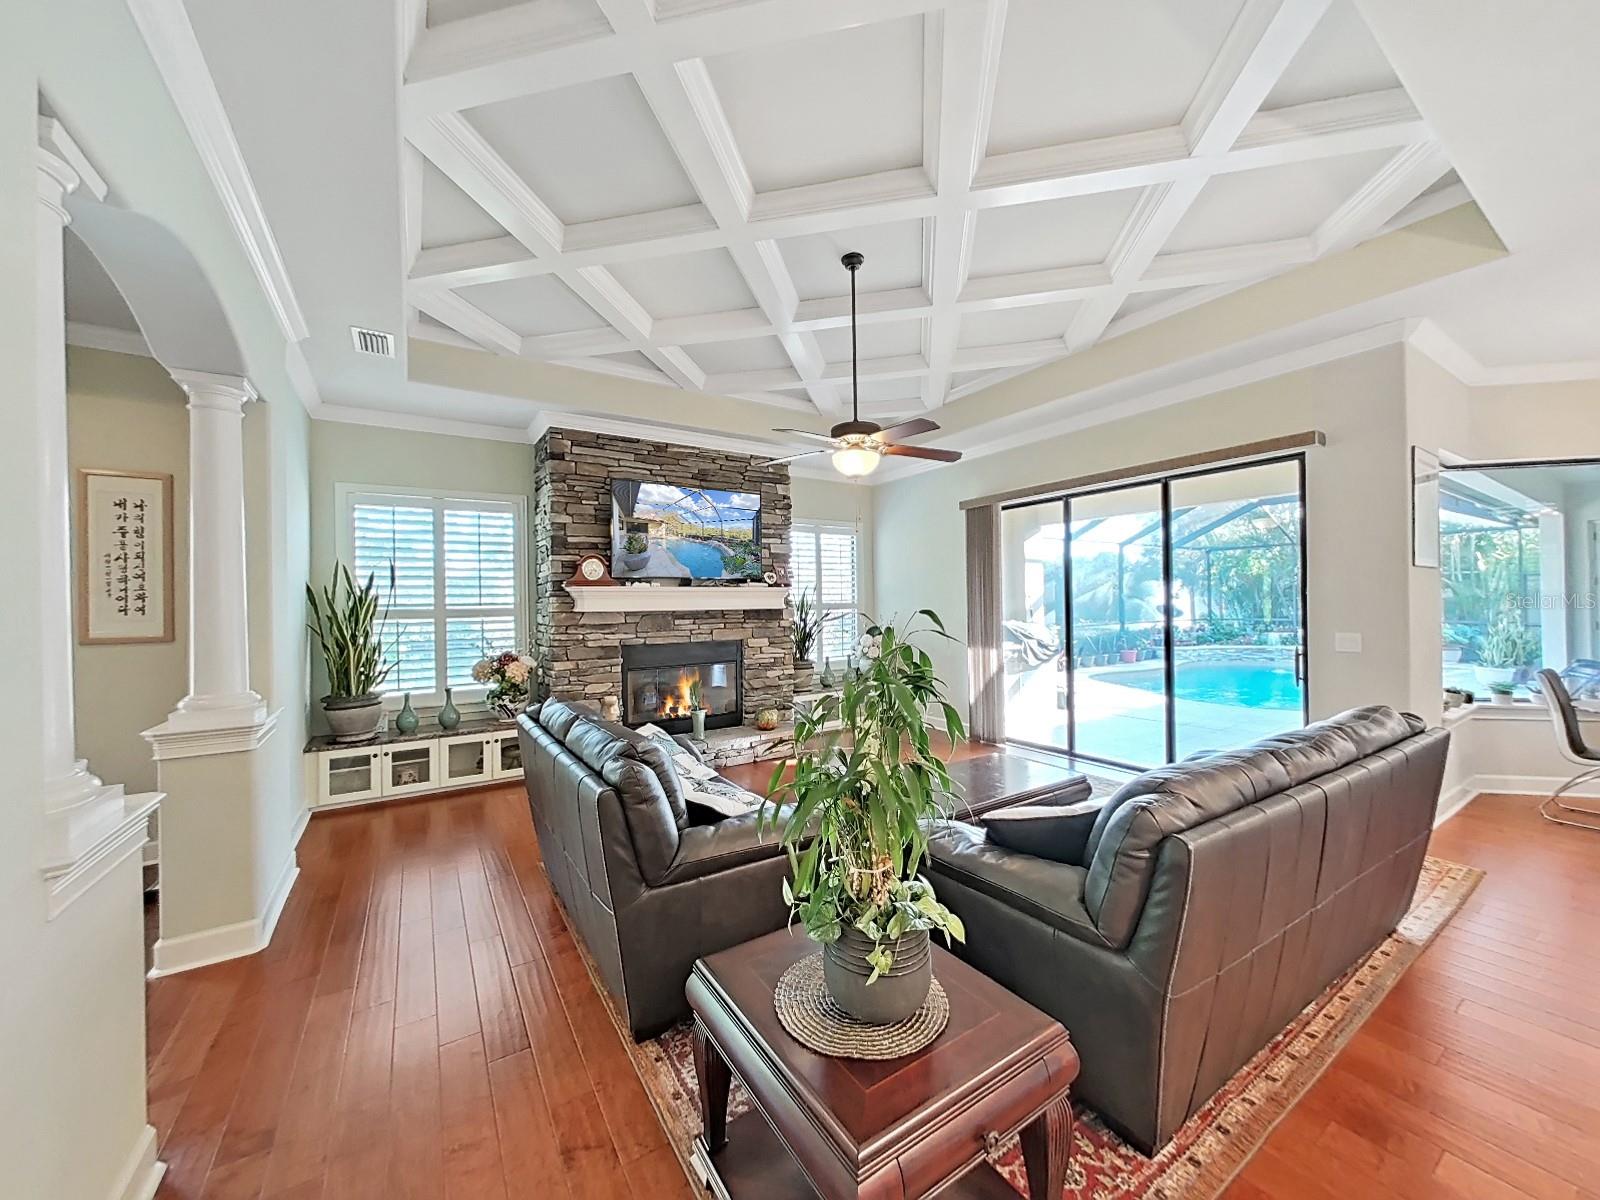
left=1002, top=458, right=1306, bottom=766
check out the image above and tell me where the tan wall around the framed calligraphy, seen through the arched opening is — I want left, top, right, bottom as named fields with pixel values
left=67, top=347, right=189, bottom=792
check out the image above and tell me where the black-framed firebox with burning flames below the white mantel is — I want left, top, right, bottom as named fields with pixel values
left=622, top=642, right=744, bottom=733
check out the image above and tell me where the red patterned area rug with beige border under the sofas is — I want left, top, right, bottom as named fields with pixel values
left=602, top=858, right=1483, bottom=1200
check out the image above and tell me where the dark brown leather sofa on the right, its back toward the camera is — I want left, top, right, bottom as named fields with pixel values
left=931, top=707, right=1450, bottom=1152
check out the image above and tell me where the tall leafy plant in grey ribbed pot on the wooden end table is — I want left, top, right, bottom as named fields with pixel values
left=762, top=610, right=966, bottom=1024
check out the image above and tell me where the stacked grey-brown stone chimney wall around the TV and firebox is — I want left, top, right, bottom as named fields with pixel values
left=531, top=429, right=794, bottom=731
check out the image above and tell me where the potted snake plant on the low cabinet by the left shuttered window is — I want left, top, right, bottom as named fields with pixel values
left=306, top=563, right=394, bottom=742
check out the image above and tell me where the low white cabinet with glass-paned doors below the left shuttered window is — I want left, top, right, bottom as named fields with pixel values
left=306, top=725, right=522, bottom=808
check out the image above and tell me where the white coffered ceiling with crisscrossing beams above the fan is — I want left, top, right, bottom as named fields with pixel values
left=402, top=0, right=1450, bottom=416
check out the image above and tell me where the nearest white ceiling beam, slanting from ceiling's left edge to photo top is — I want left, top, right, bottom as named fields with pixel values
left=402, top=0, right=952, bottom=120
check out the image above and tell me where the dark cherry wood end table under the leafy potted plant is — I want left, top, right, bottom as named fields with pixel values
left=688, top=930, right=1078, bottom=1200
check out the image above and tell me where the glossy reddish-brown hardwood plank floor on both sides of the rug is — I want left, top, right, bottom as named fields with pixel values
left=149, top=771, right=1600, bottom=1200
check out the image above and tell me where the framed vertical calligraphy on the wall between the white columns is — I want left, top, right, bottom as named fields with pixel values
left=78, top=467, right=173, bottom=645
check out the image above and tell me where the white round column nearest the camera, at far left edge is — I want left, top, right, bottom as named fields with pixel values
left=35, top=118, right=123, bottom=869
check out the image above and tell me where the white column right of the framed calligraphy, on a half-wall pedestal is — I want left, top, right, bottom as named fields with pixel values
left=168, top=370, right=267, bottom=731
